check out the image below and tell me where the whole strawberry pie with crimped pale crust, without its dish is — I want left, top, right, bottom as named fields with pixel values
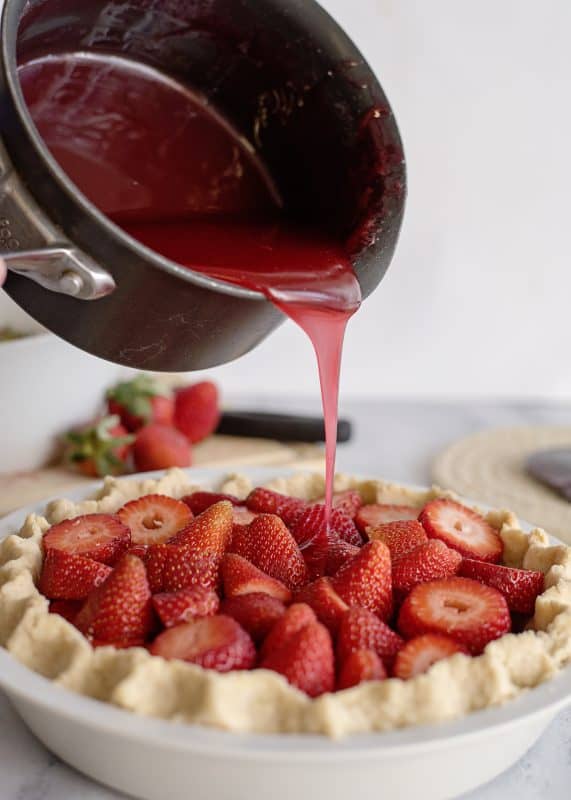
left=0, top=469, right=571, bottom=737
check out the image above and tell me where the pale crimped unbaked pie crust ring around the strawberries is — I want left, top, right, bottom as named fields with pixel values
left=0, top=470, right=571, bottom=737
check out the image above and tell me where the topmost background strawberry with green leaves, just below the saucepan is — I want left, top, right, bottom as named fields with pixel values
left=107, top=375, right=174, bottom=431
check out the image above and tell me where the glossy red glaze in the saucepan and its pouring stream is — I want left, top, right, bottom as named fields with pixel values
left=19, top=54, right=361, bottom=523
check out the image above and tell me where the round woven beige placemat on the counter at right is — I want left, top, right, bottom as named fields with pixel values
left=432, top=426, right=571, bottom=544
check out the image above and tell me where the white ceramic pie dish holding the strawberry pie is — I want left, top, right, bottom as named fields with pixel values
left=0, top=462, right=571, bottom=800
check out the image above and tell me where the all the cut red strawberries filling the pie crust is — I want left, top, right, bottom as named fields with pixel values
left=39, top=489, right=543, bottom=697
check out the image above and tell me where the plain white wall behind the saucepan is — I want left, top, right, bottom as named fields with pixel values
left=202, top=0, right=571, bottom=397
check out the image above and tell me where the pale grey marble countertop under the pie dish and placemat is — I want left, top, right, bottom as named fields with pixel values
left=0, top=398, right=571, bottom=800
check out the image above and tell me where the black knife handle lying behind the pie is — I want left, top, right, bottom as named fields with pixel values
left=217, top=411, right=351, bottom=443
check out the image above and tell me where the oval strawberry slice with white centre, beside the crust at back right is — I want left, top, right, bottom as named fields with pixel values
left=419, top=498, right=503, bottom=562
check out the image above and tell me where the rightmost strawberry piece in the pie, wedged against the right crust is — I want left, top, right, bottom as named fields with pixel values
left=459, top=558, right=545, bottom=616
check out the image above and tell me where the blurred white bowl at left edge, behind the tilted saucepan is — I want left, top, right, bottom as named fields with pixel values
left=0, top=292, right=121, bottom=473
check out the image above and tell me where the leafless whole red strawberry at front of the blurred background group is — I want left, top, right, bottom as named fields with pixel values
left=133, top=422, right=192, bottom=472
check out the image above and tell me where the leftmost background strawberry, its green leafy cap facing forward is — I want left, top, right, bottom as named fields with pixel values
left=64, top=416, right=134, bottom=478
